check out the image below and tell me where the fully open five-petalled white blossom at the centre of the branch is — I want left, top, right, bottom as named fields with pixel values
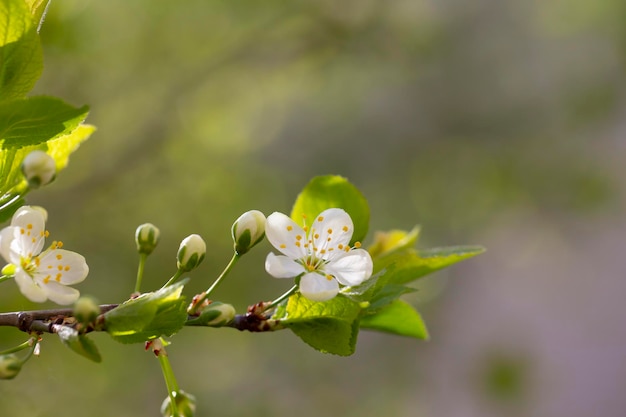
left=265, top=208, right=373, bottom=301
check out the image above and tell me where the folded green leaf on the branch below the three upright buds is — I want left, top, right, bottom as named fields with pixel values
left=104, top=279, right=189, bottom=343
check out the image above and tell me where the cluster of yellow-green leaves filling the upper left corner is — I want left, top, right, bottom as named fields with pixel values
left=0, top=0, right=94, bottom=221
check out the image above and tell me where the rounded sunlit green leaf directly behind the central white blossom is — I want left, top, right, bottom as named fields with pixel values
left=291, top=175, right=370, bottom=244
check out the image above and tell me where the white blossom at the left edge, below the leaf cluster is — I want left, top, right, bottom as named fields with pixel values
left=0, top=206, right=89, bottom=304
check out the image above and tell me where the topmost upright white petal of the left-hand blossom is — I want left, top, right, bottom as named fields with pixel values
left=11, top=206, right=46, bottom=257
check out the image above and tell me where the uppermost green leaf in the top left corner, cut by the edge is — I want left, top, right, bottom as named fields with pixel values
left=0, top=0, right=43, bottom=100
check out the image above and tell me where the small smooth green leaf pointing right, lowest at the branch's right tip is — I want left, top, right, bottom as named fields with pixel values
left=360, top=300, right=428, bottom=340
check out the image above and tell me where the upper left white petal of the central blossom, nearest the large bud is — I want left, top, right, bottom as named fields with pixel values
left=265, top=212, right=306, bottom=259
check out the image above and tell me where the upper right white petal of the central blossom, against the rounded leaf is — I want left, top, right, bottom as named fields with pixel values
left=311, top=208, right=354, bottom=260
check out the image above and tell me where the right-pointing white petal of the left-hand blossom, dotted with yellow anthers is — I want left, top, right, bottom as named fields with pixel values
left=35, top=249, right=89, bottom=284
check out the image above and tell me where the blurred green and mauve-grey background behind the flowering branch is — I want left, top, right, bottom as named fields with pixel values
left=0, top=0, right=626, bottom=417
